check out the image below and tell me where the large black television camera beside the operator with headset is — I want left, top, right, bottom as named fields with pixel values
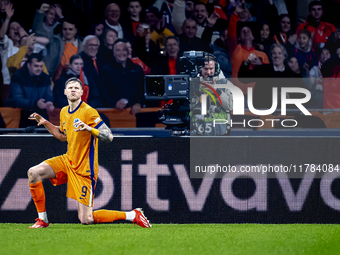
left=144, top=51, right=231, bottom=136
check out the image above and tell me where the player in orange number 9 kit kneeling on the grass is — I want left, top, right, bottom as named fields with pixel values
left=28, top=78, right=151, bottom=228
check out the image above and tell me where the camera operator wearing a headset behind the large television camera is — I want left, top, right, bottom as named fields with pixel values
left=194, top=54, right=233, bottom=136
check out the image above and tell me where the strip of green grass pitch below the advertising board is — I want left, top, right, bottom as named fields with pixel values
left=0, top=223, right=340, bottom=255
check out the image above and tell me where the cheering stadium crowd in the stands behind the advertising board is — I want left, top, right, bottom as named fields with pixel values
left=0, top=0, right=340, bottom=126
